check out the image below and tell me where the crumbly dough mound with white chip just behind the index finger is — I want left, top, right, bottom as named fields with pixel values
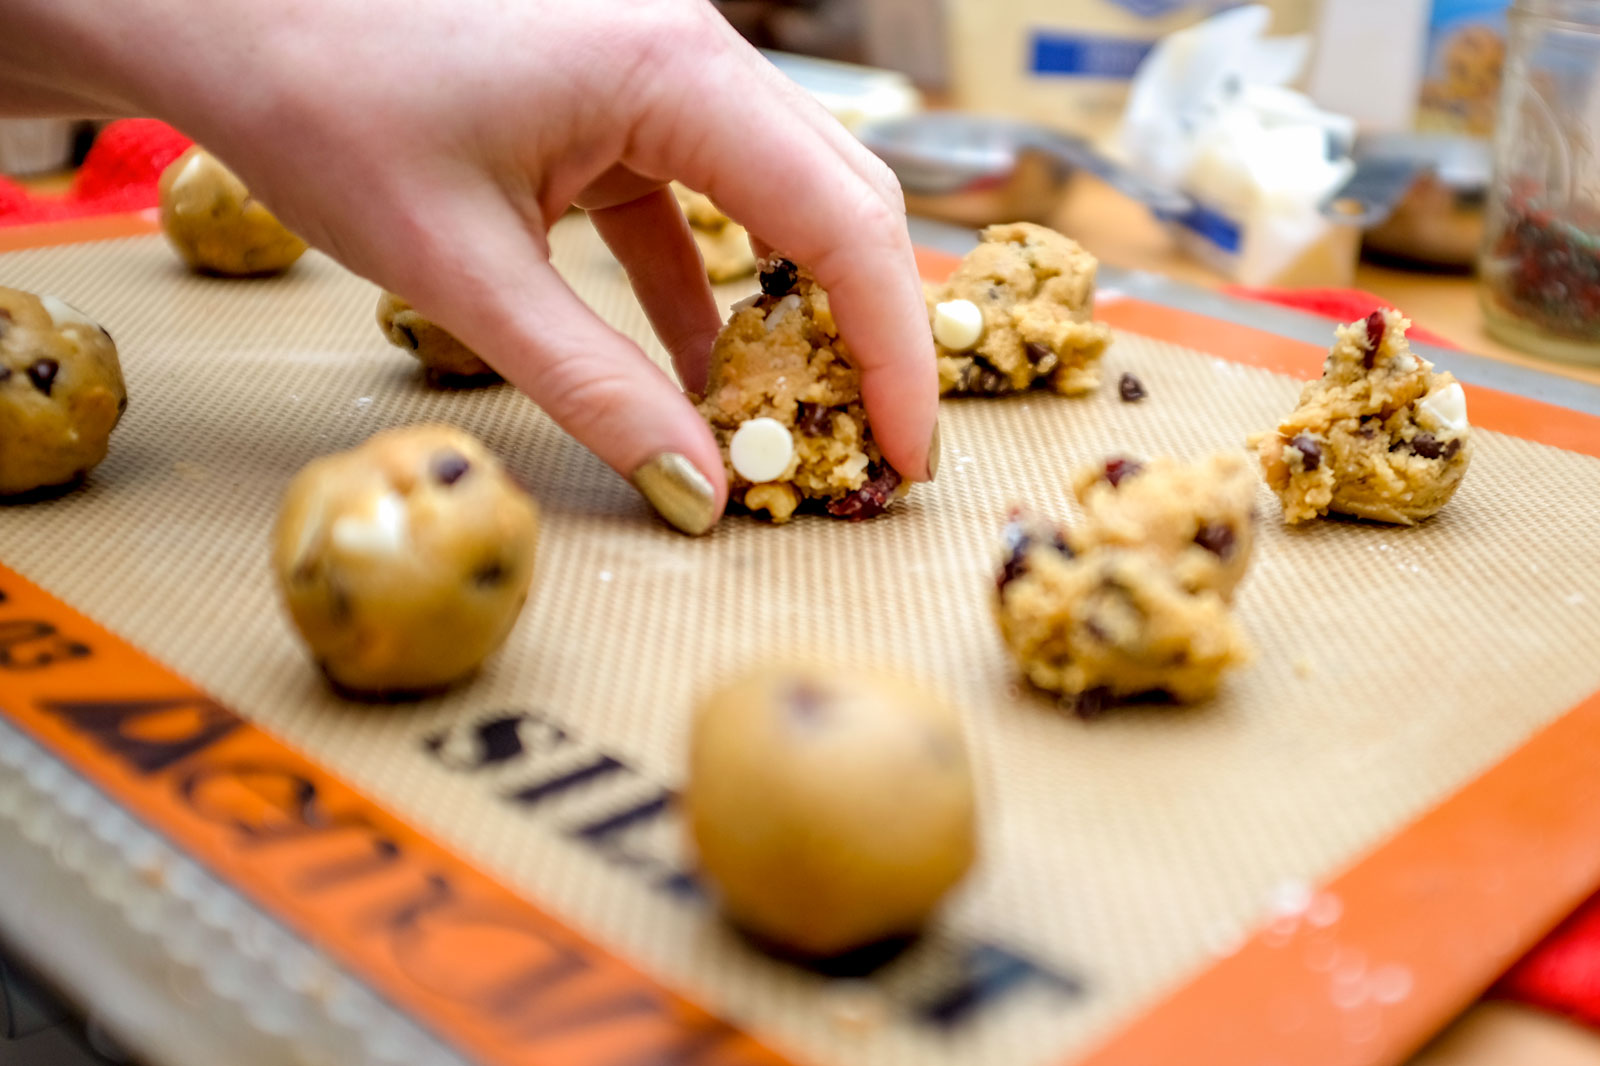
left=925, top=222, right=1110, bottom=395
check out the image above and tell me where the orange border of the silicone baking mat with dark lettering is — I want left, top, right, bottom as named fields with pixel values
left=0, top=219, right=1600, bottom=1066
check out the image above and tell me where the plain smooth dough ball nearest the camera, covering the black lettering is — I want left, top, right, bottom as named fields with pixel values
left=683, top=667, right=976, bottom=957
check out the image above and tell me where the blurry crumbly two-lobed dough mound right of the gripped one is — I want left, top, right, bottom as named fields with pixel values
left=995, top=455, right=1254, bottom=704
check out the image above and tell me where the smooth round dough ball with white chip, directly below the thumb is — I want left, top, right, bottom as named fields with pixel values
left=272, top=426, right=539, bottom=695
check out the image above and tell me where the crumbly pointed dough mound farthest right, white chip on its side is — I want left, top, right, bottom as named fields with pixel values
left=1250, top=311, right=1472, bottom=525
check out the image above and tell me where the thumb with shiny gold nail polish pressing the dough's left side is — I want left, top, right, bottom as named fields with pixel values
left=396, top=187, right=726, bottom=535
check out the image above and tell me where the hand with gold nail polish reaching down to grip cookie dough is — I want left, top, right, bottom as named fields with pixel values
left=0, top=0, right=938, bottom=528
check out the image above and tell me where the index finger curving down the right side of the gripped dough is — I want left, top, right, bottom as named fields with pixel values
left=629, top=42, right=939, bottom=479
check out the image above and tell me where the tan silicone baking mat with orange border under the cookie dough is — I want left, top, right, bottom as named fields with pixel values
left=0, top=218, right=1600, bottom=1066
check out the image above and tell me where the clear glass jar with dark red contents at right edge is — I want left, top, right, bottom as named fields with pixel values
left=1478, top=0, right=1600, bottom=365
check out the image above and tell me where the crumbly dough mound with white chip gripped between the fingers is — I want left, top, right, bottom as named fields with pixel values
left=699, top=259, right=909, bottom=522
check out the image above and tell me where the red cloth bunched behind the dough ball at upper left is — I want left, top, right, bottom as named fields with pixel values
left=0, top=118, right=192, bottom=226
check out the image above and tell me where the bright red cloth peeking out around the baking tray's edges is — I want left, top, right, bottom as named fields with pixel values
left=0, top=128, right=1600, bottom=1026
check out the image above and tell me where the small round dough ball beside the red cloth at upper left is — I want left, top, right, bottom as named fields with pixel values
left=160, top=144, right=306, bottom=277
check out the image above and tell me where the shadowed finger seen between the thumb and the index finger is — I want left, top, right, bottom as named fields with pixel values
left=589, top=186, right=722, bottom=394
